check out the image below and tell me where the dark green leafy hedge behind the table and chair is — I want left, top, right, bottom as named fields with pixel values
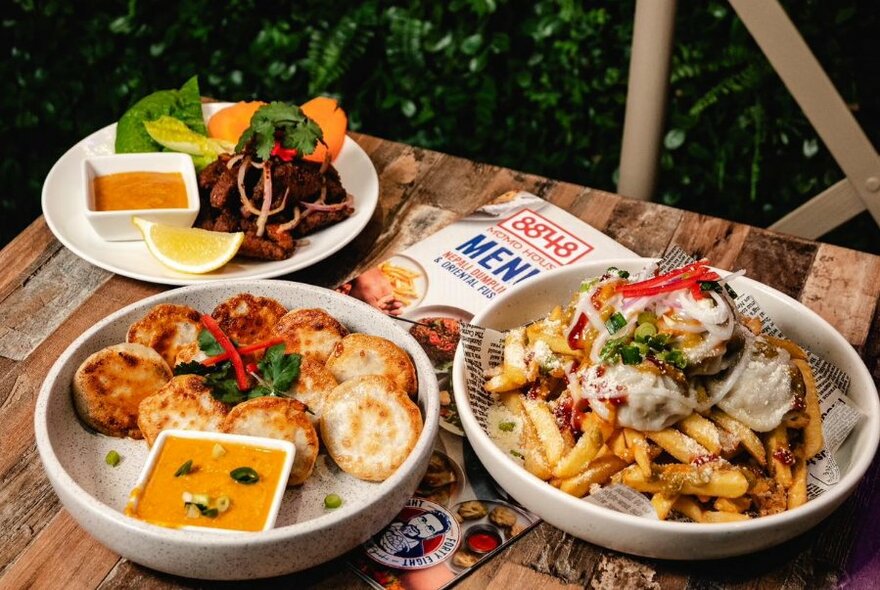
left=0, top=0, right=880, bottom=251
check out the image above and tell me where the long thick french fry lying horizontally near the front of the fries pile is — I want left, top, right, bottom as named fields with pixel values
left=621, top=464, right=749, bottom=498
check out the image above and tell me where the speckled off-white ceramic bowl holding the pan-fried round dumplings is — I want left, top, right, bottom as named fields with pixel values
left=34, top=281, right=440, bottom=580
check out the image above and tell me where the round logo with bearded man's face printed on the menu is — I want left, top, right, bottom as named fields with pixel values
left=365, top=498, right=461, bottom=570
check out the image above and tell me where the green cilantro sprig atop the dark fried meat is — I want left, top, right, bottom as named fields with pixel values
left=235, top=101, right=324, bottom=161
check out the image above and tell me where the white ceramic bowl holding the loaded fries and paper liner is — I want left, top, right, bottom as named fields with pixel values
left=453, top=258, right=880, bottom=560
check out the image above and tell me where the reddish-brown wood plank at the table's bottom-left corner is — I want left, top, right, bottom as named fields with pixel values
left=2, top=510, right=118, bottom=588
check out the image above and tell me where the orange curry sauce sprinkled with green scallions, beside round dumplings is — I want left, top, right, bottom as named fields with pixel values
left=126, top=433, right=292, bottom=531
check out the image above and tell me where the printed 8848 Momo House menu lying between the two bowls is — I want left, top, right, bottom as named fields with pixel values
left=339, top=191, right=636, bottom=590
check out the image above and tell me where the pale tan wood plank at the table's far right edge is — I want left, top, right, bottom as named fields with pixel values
left=800, top=244, right=880, bottom=348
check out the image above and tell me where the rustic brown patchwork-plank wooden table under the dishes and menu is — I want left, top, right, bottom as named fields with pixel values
left=0, top=134, right=880, bottom=589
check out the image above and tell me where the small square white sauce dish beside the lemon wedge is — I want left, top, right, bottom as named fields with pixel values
left=82, top=152, right=199, bottom=242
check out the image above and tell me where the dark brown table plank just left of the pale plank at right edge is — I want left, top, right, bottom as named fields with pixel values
left=733, top=229, right=818, bottom=299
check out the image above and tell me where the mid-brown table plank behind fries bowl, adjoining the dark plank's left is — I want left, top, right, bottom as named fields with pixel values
left=670, top=212, right=750, bottom=270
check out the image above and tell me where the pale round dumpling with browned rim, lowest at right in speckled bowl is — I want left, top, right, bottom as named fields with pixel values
left=321, top=375, right=422, bottom=481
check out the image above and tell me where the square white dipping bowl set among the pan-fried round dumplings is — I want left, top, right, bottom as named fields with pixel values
left=127, top=430, right=296, bottom=534
